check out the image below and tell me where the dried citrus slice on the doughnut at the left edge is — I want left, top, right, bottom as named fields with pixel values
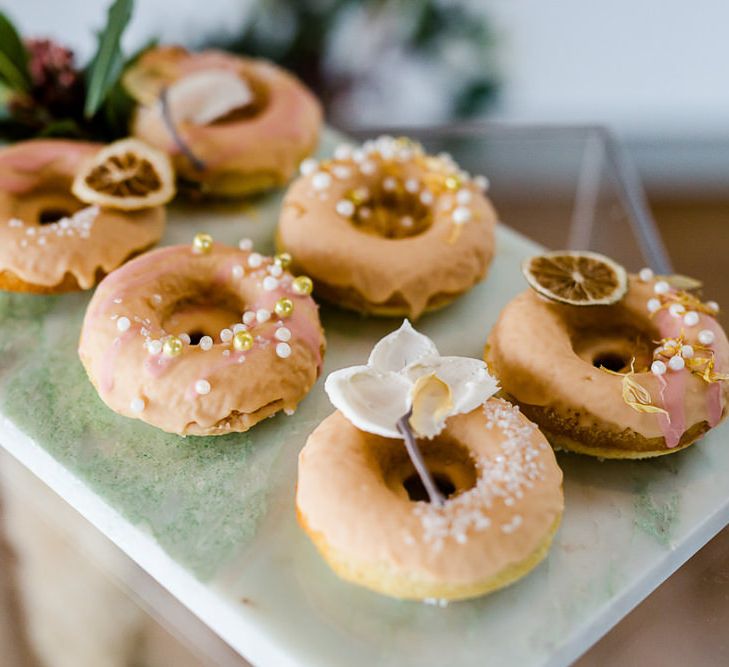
left=71, top=139, right=175, bottom=211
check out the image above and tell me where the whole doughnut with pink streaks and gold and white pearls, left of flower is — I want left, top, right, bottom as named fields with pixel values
left=79, top=234, right=325, bottom=435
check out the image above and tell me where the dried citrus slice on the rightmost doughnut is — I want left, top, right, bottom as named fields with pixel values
left=522, top=250, right=628, bottom=306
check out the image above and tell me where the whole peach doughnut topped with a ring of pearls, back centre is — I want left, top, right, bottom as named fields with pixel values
left=277, top=137, right=496, bottom=319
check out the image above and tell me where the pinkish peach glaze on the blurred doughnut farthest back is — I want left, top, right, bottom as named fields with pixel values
left=133, top=47, right=322, bottom=180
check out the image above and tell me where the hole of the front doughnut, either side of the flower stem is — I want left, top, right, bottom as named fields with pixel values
left=377, top=434, right=478, bottom=502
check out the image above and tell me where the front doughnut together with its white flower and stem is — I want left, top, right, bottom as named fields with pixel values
left=296, top=321, right=563, bottom=600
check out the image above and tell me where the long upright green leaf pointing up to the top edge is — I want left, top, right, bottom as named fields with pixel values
left=84, top=0, right=134, bottom=118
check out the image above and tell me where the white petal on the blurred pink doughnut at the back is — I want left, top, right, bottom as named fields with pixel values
left=167, top=69, right=253, bottom=125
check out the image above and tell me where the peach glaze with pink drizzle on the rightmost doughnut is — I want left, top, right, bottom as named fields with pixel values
left=488, top=276, right=729, bottom=448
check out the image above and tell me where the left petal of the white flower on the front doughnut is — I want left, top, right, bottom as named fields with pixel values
left=324, top=366, right=412, bottom=439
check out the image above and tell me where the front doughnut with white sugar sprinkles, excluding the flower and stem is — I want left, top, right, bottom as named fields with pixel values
left=296, top=398, right=563, bottom=600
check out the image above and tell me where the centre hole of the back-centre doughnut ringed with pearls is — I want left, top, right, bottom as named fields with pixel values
left=351, top=179, right=433, bottom=239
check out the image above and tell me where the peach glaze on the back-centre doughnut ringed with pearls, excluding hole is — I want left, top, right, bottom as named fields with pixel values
left=278, top=149, right=496, bottom=319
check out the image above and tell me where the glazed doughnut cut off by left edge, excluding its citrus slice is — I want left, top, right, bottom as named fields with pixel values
left=0, top=139, right=165, bottom=294
